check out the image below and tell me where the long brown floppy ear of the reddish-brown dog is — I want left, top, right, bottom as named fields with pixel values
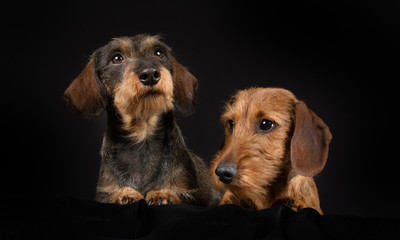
left=290, top=101, right=332, bottom=177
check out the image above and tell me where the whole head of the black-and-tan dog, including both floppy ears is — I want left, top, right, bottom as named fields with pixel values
left=64, top=34, right=197, bottom=141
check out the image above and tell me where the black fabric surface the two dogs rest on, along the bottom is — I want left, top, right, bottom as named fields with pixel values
left=2, top=197, right=400, bottom=240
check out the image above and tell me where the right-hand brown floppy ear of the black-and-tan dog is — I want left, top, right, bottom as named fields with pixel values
left=172, top=58, right=198, bottom=113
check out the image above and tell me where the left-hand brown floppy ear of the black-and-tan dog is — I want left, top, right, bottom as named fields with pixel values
left=63, top=58, right=106, bottom=117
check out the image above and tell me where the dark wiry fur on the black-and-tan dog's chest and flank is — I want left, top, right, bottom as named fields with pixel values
left=96, top=111, right=211, bottom=206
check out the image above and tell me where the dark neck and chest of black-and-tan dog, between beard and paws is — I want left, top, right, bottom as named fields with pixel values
left=100, top=111, right=189, bottom=192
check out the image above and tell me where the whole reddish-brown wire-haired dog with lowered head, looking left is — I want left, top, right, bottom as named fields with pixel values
left=210, top=88, right=332, bottom=214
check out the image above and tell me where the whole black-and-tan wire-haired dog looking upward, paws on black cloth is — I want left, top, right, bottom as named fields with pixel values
left=64, top=34, right=217, bottom=206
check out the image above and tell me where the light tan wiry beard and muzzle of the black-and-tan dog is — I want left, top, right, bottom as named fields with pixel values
left=114, top=67, right=174, bottom=142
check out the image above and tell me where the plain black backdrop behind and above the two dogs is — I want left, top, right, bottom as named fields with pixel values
left=0, top=1, right=400, bottom=217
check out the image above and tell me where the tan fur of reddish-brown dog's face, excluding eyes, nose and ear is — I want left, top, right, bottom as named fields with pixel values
left=210, top=88, right=297, bottom=209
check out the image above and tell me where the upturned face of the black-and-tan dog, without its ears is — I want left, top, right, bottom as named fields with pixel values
left=94, top=35, right=173, bottom=119
